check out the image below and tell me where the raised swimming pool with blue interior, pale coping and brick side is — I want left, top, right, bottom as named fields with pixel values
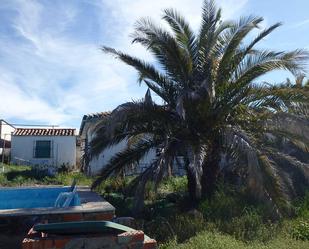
left=0, top=186, right=115, bottom=249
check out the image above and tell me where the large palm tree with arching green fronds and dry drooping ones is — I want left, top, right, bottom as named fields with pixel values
left=92, top=0, right=309, bottom=214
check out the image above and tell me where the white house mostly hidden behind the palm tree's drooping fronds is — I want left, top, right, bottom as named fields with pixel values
left=79, top=112, right=155, bottom=175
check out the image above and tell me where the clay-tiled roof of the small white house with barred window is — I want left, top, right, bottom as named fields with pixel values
left=13, top=128, right=75, bottom=136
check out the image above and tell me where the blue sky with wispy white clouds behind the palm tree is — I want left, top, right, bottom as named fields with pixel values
left=0, top=0, right=309, bottom=128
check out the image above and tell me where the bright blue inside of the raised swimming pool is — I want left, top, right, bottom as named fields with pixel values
left=0, top=187, right=80, bottom=209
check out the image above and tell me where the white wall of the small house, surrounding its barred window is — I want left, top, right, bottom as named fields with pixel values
left=11, top=135, right=76, bottom=167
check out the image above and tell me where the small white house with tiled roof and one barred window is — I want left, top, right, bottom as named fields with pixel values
left=11, top=128, right=76, bottom=167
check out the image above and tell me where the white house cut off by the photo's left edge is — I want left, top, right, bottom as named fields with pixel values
left=0, top=119, right=15, bottom=161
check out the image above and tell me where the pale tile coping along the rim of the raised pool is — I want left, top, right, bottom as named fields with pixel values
left=0, top=185, right=115, bottom=218
